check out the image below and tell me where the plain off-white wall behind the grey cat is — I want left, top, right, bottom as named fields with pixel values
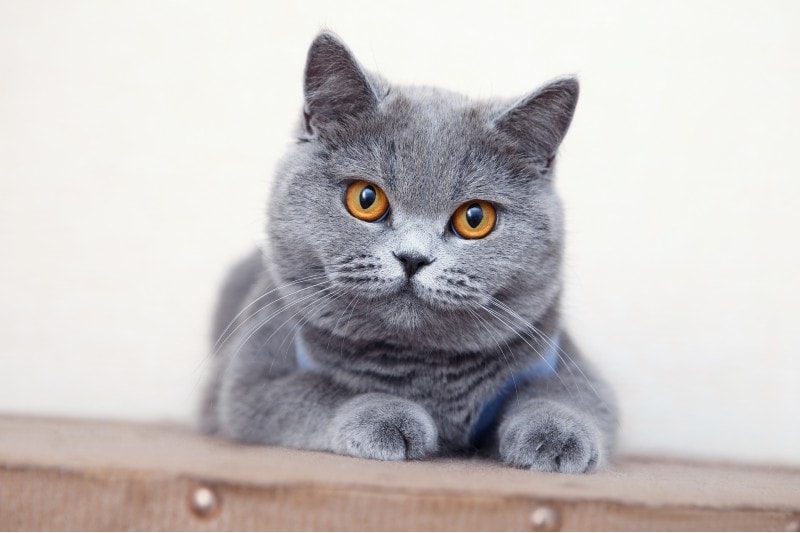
left=0, top=1, right=800, bottom=464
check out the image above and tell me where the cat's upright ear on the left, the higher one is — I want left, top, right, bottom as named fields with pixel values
left=304, top=32, right=378, bottom=136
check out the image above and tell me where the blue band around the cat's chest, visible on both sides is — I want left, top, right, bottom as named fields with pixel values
left=294, top=333, right=561, bottom=447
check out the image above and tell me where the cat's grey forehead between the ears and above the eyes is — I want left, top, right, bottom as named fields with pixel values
left=344, top=87, right=517, bottom=204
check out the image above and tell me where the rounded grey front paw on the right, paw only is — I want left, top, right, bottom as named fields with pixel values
left=500, top=400, right=601, bottom=474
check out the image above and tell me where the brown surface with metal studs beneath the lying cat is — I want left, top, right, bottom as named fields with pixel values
left=0, top=416, right=800, bottom=531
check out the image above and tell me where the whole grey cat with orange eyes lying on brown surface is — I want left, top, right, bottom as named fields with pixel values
left=201, top=32, right=617, bottom=472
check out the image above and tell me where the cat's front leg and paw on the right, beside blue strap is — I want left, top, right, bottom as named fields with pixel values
left=494, top=334, right=617, bottom=473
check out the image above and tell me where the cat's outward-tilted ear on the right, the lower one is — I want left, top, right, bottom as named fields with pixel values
left=494, top=78, right=579, bottom=168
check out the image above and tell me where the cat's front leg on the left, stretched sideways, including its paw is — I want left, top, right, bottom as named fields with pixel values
left=218, top=358, right=438, bottom=460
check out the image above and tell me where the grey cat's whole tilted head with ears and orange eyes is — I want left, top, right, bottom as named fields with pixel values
left=267, top=33, right=578, bottom=349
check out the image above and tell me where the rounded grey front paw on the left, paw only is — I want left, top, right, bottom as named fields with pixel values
left=331, top=393, right=438, bottom=460
